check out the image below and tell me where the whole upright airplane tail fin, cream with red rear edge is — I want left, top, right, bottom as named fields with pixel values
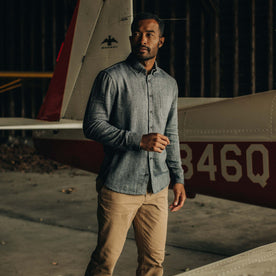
left=38, top=0, right=132, bottom=121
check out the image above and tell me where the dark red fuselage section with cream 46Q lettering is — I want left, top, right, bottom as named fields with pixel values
left=181, top=142, right=276, bottom=208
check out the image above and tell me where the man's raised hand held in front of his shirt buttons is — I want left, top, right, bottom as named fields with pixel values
left=140, top=133, right=170, bottom=153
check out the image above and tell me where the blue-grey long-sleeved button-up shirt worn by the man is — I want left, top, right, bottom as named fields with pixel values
left=83, top=54, right=184, bottom=195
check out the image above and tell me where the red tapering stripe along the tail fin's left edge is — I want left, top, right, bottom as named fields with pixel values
left=37, top=0, right=80, bottom=121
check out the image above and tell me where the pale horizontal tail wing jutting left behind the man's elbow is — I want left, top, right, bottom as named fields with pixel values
left=0, top=118, right=82, bottom=130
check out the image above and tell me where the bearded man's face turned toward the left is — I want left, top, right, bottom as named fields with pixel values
left=130, top=19, right=164, bottom=61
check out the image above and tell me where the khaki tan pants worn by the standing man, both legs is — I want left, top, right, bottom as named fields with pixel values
left=85, top=187, right=168, bottom=276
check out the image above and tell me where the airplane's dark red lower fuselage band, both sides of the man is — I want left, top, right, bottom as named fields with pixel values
left=34, top=138, right=276, bottom=208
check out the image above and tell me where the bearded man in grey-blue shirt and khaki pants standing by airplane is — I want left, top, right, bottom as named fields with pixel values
left=83, top=11, right=186, bottom=276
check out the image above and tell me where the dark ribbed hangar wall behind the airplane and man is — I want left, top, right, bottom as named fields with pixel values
left=0, top=0, right=276, bottom=138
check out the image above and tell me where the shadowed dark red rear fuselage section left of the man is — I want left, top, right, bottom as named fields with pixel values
left=34, top=138, right=104, bottom=173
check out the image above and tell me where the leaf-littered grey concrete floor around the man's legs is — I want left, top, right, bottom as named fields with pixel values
left=0, top=169, right=276, bottom=276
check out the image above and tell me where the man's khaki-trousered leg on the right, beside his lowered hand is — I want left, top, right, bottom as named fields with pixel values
left=133, top=188, right=168, bottom=276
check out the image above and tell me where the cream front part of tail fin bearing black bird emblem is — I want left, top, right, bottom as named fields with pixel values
left=61, top=0, right=132, bottom=120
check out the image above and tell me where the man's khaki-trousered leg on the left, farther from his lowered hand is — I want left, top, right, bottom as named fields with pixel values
left=85, top=187, right=144, bottom=276
